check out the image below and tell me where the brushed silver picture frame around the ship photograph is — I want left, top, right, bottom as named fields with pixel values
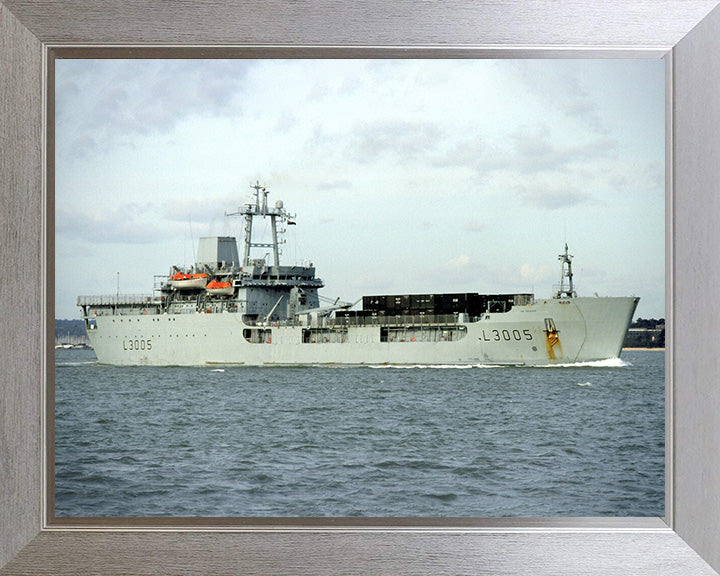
left=0, top=0, right=720, bottom=574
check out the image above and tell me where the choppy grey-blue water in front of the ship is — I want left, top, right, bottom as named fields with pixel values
left=55, top=350, right=665, bottom=517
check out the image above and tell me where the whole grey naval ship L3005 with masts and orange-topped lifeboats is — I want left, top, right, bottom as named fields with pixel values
left=77, top=182, right=639, bottom=366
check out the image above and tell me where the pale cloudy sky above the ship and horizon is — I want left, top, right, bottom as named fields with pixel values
left=55, top=59, right=665, bottom=318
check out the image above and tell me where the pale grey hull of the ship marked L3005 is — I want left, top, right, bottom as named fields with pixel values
left=88, top=297, right=638, bottom=366
